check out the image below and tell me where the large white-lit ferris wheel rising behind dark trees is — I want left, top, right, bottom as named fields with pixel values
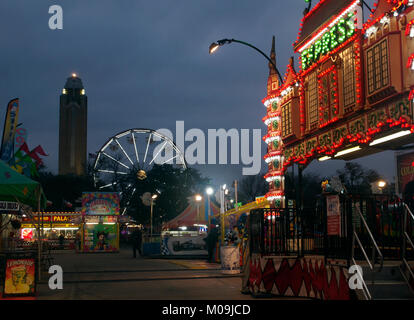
left=93, top=129, right=187, bottom=214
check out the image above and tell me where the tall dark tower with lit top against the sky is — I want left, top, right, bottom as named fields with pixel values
left=59, top=74, right=88, bottom=175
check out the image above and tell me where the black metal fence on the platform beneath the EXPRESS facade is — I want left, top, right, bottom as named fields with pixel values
left=249, top=194, right=414, bottom=262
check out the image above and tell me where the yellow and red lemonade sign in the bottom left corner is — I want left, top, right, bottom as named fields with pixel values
left=3, top=259, right=36, bottom=297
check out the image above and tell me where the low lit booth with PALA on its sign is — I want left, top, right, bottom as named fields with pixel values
left=19, top=212, right=82, bottom=249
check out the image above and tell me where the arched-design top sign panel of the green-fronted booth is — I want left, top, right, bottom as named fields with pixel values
left=82, top=192, right=119, bottom=216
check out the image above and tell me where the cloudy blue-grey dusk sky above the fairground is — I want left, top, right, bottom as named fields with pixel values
left=0, top=0, right=395, bottom=188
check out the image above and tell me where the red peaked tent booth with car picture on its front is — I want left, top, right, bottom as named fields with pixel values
left=161, top=201, right=219, bottom=256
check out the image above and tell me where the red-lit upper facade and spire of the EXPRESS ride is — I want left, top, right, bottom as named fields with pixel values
left=263, top=0, right=414, bottom=207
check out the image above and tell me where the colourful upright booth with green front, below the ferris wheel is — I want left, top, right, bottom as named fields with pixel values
left=81, top=192, right=119, bottom=253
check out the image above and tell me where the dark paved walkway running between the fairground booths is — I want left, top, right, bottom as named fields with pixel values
left=38, top=249, right=253, bottom=300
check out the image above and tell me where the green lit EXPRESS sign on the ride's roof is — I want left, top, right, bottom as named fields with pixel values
left=301, top=13, right=355, bottom=70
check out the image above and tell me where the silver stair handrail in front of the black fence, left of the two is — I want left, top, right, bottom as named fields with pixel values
left=352, top=203, right=384, bottom=300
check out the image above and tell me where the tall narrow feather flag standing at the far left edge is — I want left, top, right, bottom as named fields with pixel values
left=0, top=98, right=19, bottom=163
